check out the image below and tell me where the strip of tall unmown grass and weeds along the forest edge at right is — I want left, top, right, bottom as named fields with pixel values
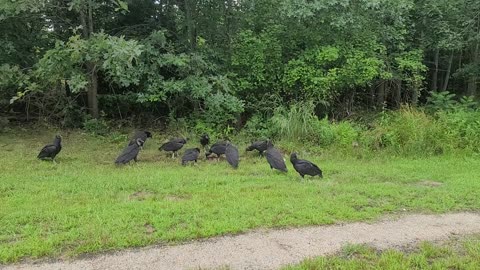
left=260, top=103, right=480, bottom=156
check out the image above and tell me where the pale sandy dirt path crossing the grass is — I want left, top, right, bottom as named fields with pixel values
left=0, top=213, right=480, bottom=270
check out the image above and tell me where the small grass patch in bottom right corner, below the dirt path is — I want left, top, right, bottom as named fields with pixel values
left=284, top=236, right=480, bottom=270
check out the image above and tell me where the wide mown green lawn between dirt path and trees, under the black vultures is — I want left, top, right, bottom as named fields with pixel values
left=0, top=130, right=480, bottom=263
